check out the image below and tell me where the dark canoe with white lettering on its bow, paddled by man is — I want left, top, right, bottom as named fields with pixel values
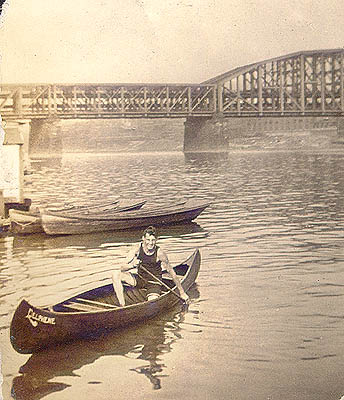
left=10, top=250, right=201, bottom=354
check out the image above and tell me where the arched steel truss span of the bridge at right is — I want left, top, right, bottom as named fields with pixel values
left=205, top=49, right=344, bottom=116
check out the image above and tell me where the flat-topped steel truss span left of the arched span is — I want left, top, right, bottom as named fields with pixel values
left=0, top=84, right=216, bottom=118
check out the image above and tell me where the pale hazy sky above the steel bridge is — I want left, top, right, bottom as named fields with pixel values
left=0, top=0, right=344, bottom=83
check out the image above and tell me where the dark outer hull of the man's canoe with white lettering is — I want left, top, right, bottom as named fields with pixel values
left=10, top=250, right=200, bottom=354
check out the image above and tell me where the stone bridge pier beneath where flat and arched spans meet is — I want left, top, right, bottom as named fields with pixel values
left=184, top=116, right=229, bottom=153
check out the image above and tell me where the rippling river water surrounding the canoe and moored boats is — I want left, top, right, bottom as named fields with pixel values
left=0, top=151, right=344, bottom=400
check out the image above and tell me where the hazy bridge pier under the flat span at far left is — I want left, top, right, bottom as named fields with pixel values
left=29, top=119, right=62, bottom=155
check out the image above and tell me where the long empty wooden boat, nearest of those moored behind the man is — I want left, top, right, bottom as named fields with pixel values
left=42, top=200, right=209, bottom=235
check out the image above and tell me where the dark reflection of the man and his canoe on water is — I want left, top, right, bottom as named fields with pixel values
left=11, top=285, right=200, bottom=400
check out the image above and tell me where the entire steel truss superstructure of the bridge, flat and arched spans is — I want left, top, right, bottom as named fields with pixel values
left=0, top=49, right=344, bottom=119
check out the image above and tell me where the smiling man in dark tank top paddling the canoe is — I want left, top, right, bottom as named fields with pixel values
left=112, top=226, right=189, bottom=306
